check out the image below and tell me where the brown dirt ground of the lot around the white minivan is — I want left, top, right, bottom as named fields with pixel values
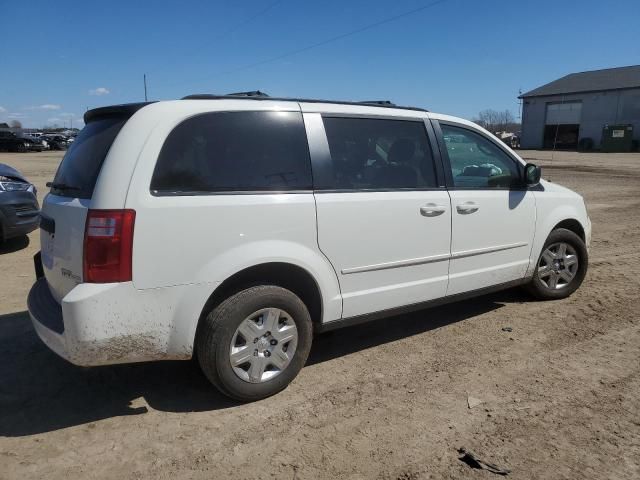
left=0, top=151, right=640, bottom=480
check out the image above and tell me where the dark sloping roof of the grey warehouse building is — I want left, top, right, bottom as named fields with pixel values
left=518, top=65, right=640, bottom=98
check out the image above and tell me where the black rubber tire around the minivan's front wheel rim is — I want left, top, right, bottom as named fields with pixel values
left=526, top=228, right=589, bottom=300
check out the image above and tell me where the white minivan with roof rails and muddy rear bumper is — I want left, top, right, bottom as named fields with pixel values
left=28, top=94, right=591, bottom=400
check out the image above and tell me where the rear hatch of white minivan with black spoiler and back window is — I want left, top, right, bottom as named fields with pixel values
left=40, top=104, right=146, bottom=302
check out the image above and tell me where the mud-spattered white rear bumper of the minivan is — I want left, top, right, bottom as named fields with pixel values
left=28, top=278, right=212, bottom=366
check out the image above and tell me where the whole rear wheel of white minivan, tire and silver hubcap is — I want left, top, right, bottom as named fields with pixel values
left=196, top=285, right=313, bottom=401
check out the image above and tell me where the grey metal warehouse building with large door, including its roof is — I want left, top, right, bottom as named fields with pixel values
left=519, top=65, right=640, bottom=148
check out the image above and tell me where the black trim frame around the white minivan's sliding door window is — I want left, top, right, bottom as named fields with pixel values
left=310, top=112, right=447, bottom=194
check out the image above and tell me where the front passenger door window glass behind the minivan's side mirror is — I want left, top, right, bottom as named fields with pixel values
left=441, top=125, right=520, bottom=188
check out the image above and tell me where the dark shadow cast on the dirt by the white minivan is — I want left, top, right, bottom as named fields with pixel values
left=0, top=291, right=526, bottom=437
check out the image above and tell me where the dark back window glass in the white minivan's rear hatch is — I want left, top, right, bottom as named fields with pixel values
left=51, top=117, right=127, bottom=198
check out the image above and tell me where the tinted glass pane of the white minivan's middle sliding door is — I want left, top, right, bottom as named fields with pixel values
left=323, top=117, right=436, bottom=190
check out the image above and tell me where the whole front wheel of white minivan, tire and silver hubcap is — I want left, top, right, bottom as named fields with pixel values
left=527, top=228, right=589, bottom=300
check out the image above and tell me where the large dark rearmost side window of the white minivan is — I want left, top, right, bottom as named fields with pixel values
left=151, top=112, right=312, bottom=195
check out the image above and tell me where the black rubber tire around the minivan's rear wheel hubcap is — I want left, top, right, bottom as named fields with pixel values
left=196, top=285, right=313, bottom=401
